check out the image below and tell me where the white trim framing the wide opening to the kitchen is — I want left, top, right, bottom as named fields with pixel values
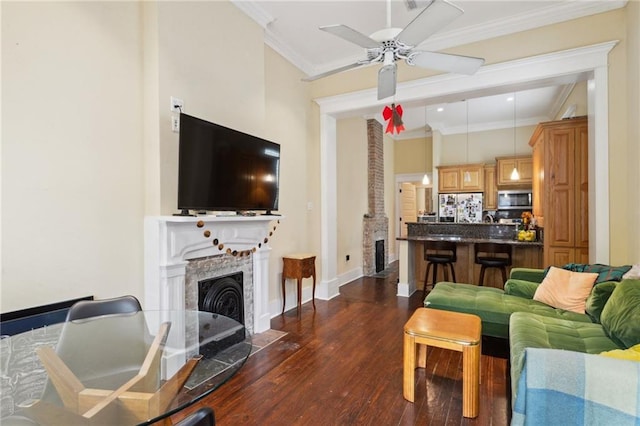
left=315, top=40, right=618, bottom=297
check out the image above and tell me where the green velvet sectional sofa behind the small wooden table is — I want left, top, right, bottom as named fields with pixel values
left=424, top=265, right=640, bottom=401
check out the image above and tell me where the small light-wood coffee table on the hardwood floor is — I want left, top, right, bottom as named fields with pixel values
left=403, top=308, right=482, bottom=417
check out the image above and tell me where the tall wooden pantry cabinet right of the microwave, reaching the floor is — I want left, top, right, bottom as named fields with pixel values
left=529, top=117, right=589, bottom=266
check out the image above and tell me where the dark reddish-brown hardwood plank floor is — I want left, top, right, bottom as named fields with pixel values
left=174, top=265, right=510, bottom=426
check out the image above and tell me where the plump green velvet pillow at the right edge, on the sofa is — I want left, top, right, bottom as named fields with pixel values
left=600, top=280, right=640, bottom=348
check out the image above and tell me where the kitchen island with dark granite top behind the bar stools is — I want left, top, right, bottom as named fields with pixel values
left=398, top=223, right=543, bottom=297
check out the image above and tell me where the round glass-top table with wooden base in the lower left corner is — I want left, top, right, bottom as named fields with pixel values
left=0, top=311, right=251, bottom=425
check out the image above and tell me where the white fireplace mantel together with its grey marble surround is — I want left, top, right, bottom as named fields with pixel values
left=144, top=216, right=280, bottom=334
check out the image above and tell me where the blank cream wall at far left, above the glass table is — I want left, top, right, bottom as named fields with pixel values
left=0, top=2, right=143, bottom=311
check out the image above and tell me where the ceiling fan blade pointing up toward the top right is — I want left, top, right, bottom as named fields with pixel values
left=396, top=0, right=464, bottom=46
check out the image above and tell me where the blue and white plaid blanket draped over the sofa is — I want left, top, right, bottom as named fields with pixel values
left=511, top=348, right=640, bottom=426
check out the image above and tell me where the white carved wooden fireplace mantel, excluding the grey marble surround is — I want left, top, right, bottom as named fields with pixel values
left=144, top=216, right=280, bottom=333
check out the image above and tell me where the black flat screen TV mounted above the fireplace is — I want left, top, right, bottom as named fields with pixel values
left=178, top=114, right=280, bottom=214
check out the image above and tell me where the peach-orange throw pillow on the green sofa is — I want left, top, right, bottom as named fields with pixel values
left=533, top=266, right=598, bottom=314
